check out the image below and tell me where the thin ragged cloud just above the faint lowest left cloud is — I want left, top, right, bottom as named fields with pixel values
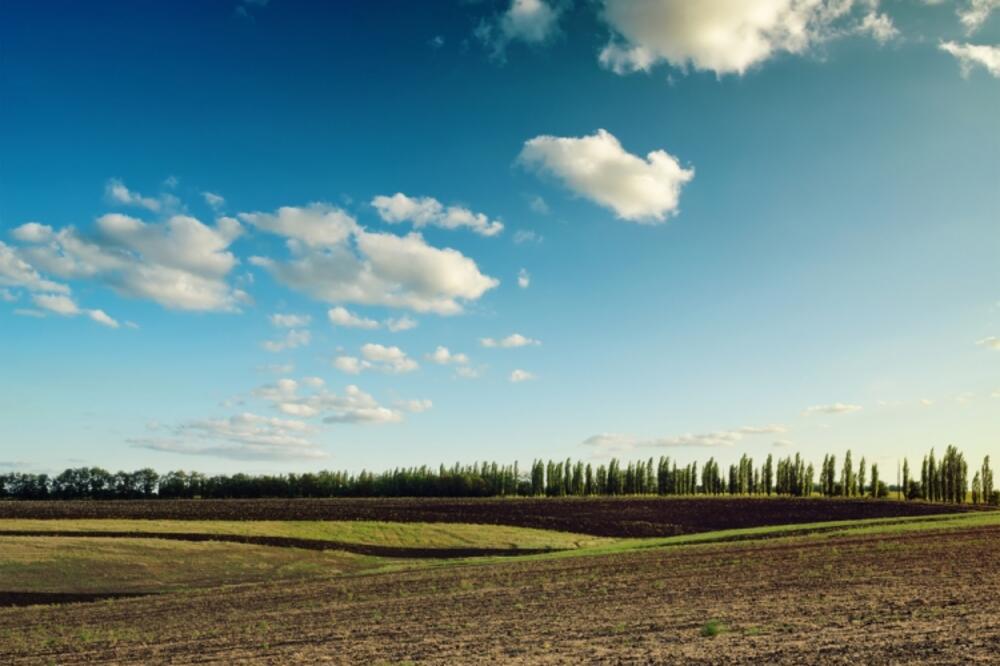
left=254, top=379, right=418, bottom=423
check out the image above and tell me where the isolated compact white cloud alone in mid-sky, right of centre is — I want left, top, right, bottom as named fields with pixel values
left=519, top=129, right=694, bottom=224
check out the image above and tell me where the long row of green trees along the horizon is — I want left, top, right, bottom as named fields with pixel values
left=0, top=446, right=1000, bottom=505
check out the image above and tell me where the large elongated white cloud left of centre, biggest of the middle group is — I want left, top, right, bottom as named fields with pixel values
left=248, top=204, right=499, bottom=314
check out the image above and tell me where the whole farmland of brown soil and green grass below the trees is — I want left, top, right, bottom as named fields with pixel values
left=0, top=499, right=1000, bottom=664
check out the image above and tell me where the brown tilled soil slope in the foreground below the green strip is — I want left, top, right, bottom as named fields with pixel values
left=0, top=527, right=1000, bottom=665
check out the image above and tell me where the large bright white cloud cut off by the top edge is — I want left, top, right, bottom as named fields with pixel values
left=599, top=0, right=895, bottom=76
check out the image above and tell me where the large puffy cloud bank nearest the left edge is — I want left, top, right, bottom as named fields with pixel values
left=11, top=213, right=249, bottom=310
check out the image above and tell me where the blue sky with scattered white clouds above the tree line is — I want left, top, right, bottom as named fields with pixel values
left=0, top=0, right=1000, bottom=473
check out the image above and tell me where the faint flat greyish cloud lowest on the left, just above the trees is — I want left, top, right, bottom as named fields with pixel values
left=129, top=412, right=328, bottom=460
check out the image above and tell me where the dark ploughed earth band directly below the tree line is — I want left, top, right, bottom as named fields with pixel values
left=0, top=497, right=972, bottom=537
